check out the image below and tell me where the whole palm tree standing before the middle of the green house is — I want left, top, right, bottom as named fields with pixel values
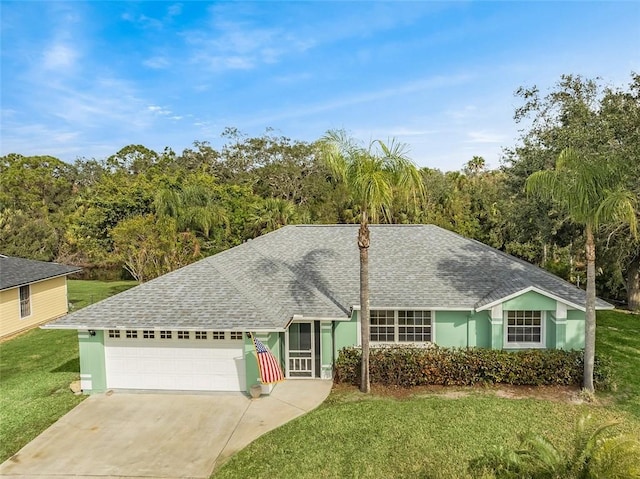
left=320, top=130, right=424, bottom=393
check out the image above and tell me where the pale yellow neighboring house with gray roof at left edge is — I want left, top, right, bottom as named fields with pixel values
left=0, top=255, right=81, bottom=339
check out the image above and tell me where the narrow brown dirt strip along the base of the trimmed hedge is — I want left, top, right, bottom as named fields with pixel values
left=333, top=384, right=586, bottom=404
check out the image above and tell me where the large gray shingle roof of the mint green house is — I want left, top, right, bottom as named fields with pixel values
left=51, top=225, right=610, bottom=330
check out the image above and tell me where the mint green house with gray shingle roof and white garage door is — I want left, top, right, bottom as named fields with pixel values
left=47, top=225, right=612, bottom=392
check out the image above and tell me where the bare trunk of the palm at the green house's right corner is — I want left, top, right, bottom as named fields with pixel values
left=583, top=224, right=596, bottom=392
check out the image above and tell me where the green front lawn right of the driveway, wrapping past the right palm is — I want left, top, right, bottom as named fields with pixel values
left=213, top=312, right=640, bottom=479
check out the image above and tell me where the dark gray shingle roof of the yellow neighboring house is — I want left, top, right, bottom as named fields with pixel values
left=0, top=255, right=82, bottom=291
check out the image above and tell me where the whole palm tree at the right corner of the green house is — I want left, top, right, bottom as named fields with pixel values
left=526, top=148, right=637, bottom=392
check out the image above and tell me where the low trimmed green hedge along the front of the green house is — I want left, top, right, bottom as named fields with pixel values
left=335, top=346, right=613, bottom=389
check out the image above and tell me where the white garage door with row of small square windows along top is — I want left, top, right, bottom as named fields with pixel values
left=105, top=330, right=246, bottom=391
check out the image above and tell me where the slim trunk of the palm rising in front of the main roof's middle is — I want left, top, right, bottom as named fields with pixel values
left=358, top=213, right=371, bottom=393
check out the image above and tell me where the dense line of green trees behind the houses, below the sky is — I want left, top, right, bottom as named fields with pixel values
left=0, top=73, right=640, bottom=309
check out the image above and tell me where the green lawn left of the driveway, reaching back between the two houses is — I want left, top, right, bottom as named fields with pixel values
left=0, top=281, right=136, bottom=462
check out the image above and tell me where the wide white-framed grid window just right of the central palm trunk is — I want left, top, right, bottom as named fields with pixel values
left=369, top=309, right=432, bottom=343
